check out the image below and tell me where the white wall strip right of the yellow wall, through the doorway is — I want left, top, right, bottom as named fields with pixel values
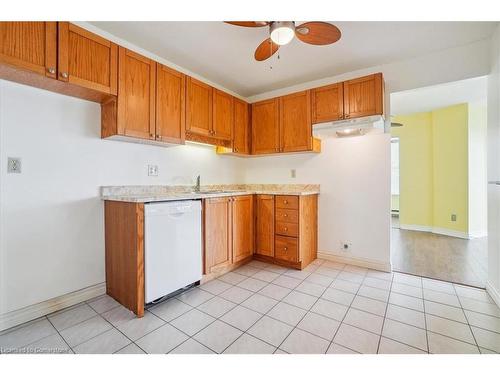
left=468, top=101, right=488, bottom=237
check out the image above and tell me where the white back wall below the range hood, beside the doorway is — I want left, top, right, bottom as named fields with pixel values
left=241, top=134, right=391, bottom=266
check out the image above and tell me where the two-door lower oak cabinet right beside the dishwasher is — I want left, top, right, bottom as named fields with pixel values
left=203, top=195, right=254, bottom=274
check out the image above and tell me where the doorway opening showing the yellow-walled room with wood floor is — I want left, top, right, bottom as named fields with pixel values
left=391, top=77, right=488, bottom=287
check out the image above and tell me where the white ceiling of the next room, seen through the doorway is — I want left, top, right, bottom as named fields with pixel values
left=391, top=77, right=488, bottom=115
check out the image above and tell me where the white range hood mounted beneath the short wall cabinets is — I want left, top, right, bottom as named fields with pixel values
left=313, top=115, right=384, bottom=138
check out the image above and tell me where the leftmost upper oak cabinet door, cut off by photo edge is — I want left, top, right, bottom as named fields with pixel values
left=0, top=22, right=57, bottom=78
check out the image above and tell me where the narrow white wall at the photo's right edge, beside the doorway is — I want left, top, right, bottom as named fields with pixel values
left=487, top=26, right=500, bottom=306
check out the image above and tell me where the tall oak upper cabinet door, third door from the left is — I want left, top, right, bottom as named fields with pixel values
left=118, top=47, right=156, bottom=139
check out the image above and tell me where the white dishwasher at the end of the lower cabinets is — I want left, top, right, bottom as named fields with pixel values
left=144, top=200, right=202, bottom=303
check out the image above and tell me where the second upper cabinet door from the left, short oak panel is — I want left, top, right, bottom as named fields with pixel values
left=58, top=22, right=118, bottom=95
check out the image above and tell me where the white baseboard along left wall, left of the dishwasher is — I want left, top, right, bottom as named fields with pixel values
left=0, top=283, right=106, bottom=331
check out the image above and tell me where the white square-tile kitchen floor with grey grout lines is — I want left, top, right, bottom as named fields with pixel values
left=0, top=260, right=500, bottom=354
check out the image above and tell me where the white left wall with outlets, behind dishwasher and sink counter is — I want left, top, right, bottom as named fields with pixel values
left=0, top=80, right=243, bottom=314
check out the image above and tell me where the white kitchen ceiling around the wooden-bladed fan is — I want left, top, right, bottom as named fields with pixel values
left=92, top=21, right=496, bottom=97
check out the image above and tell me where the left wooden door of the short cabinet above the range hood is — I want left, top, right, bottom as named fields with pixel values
left=311, top=82, right=344, bottom=124
